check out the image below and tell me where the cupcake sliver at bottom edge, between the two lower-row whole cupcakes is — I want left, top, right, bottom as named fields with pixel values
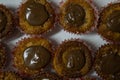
left=32, top=72, right=62, bottom=80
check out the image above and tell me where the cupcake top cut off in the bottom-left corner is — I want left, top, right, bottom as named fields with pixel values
left=0, top=71, right=23, bottom=80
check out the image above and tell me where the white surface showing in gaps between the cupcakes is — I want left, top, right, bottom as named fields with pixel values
left=0, top=0, right=117, bottom=79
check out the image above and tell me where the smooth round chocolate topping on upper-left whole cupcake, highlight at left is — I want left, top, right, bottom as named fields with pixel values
left=25, top=1, right=49, bottom=26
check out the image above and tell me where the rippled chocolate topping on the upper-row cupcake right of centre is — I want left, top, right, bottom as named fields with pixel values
left=65, top=4, right=85, bottom=27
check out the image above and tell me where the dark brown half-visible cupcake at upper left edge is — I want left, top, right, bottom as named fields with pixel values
left=0, top=4, right=14, bottom=38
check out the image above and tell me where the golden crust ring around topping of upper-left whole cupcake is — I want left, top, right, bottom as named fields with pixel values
left=18, top=0, right=55, bottom=34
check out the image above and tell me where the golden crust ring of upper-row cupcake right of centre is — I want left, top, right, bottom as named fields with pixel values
left=60, top=0, right=95, bottom=33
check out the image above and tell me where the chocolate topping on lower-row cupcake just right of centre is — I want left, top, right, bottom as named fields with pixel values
left=63, top=49, right=85, bottom=70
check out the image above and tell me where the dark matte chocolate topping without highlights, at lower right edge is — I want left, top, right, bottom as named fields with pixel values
left=101, top=54, right=120, bottom=75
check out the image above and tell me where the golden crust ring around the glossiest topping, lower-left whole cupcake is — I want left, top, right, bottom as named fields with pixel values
left=13, top=37, right=53, bottom=75
